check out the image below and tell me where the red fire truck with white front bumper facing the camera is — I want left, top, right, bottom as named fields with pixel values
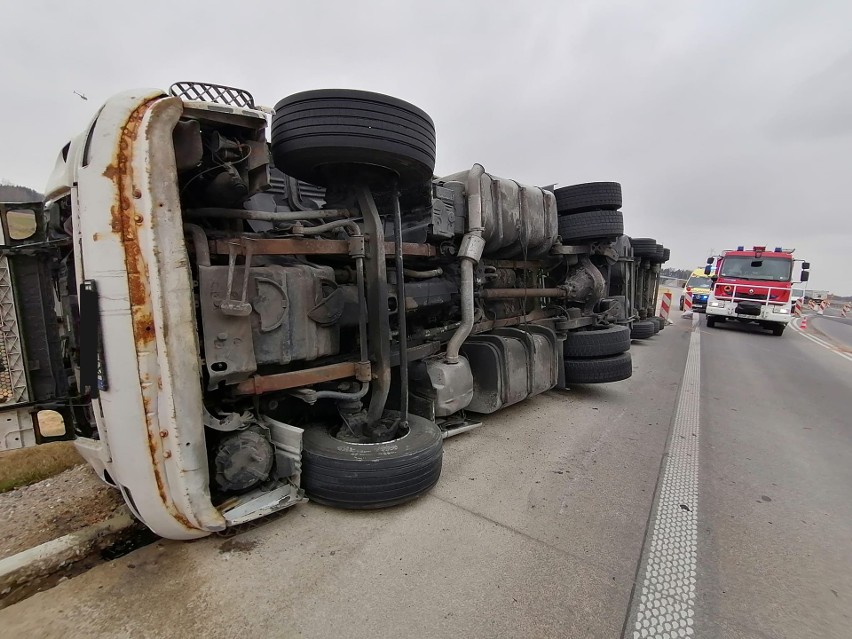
left=704, top=246, right=810, bottom=335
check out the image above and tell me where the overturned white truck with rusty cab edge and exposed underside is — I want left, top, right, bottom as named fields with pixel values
left=2, top=83, right=664, bottom=539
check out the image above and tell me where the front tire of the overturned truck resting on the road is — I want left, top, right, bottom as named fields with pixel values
left=302, top=415, right=443, bottom=509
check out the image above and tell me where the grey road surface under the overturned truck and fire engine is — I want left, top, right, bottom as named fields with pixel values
left=0, top=313, right=852, bottom=639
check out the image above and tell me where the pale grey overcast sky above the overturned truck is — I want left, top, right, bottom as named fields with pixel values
left=0, top=0, right=852, bottom=294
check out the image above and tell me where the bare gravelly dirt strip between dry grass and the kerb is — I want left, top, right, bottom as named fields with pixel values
left=0, top=464, right=124, bottom=559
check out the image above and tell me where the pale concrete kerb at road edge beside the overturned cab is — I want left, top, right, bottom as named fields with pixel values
left=0, top=508, right=134, bottom=607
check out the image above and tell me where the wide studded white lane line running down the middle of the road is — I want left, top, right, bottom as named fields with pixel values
left=633, top=317, right=701, bottom=639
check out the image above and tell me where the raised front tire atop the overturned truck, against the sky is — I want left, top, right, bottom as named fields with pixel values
left=272, top=89, right=435, bottom=187
